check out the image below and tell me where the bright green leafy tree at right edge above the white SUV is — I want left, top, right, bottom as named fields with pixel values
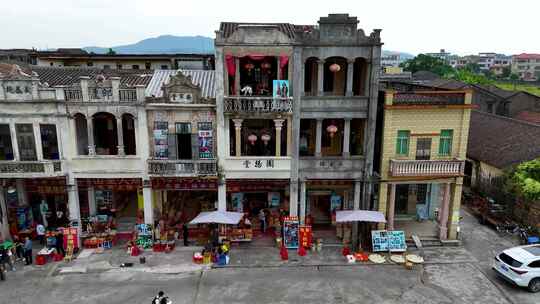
left=511, top=158, right=540, bottom=201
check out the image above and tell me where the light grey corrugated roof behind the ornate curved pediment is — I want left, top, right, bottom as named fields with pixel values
left=145, top=70, right=216, bottom=98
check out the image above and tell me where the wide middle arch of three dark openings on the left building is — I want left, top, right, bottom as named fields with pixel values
left=93, top=112, right=118, bottom=155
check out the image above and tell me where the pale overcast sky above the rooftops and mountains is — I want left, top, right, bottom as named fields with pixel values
left=0, top=0, right=540, bottom=55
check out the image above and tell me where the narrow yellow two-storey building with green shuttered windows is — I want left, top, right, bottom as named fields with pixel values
left=378, top=91, right=472, bottom=240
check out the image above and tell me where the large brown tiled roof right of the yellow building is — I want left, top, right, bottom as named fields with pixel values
left=467, top=110, right=540, bottom=169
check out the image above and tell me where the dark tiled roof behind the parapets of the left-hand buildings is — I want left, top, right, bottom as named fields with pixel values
left=32, top=66, right=153, bottom=87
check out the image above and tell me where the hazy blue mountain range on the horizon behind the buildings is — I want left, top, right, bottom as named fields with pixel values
left=83, top=35, right=414, bottom=60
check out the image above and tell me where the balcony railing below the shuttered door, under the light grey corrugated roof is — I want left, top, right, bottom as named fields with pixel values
left=148, top=159, right=217, bottom=175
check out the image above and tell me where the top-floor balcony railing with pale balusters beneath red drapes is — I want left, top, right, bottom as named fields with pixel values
left=225, top=96, right=293, bottom=113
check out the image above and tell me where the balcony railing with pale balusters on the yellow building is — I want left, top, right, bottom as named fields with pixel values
left=390, top=159, right=465, bottom=177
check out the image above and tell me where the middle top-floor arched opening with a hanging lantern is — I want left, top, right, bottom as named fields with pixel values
left=323, top=57, right=347, bottom=96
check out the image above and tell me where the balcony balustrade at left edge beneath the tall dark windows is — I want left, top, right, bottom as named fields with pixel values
left=0, top=160, right=65, bottom=178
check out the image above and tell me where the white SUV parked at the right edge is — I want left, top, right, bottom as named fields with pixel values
left=493, top=244, right=540, bottom=292
